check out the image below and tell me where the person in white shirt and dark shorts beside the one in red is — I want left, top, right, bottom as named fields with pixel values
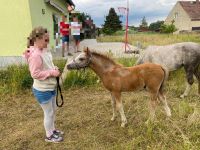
left=71, top=17, right=82, bottom=53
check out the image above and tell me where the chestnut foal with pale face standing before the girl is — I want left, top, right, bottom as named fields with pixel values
left=67, top=48, right=171, bottom=127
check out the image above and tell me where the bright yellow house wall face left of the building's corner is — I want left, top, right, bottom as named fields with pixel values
left=0, top=0, right=32, bottom=56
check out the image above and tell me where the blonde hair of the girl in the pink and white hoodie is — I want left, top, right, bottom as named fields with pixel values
left=27, top=26, right=48, bottom=48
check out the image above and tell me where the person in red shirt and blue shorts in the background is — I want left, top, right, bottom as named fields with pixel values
left=60, top=15, right=72, bottom=57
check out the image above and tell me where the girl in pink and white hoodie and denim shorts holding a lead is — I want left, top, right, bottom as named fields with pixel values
left=24, top=27, right=64, bottom=143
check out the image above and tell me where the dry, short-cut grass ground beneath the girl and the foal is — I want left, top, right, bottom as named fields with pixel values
left=0, top=84, right=200, bottom=150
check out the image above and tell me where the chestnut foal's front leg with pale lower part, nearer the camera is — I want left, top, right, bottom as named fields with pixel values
left=112, top=92, right=127, bottom=127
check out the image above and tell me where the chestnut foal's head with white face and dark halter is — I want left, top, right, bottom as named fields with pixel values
left=67, top=47, right=91, bottom=70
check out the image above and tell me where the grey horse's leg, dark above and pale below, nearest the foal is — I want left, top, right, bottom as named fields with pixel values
left=180, top=65, right=194, bottom=98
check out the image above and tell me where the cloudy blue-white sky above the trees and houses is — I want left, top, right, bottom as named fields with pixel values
left=73, top=0, right=191, bottom=27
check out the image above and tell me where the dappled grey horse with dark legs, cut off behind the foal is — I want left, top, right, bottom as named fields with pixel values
left=136, top=42, right=200, bottom=98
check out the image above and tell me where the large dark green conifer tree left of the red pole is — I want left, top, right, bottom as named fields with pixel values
left=102, top=8, right=122, bottom=35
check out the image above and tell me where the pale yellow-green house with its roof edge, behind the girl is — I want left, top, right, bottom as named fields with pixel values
left=0, top=0, right=68, bottom=56
